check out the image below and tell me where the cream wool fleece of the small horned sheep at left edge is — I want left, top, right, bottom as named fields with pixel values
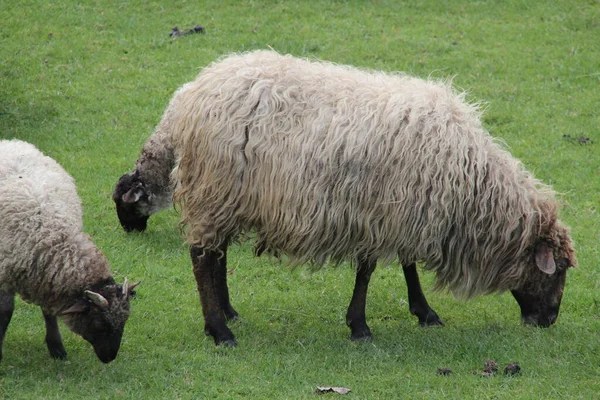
left=0, top=140, right=110, bottom=315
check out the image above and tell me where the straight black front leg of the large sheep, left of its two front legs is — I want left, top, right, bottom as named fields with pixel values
left=346, top=259, right=377, bottom=340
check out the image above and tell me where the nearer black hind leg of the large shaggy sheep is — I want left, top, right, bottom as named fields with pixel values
left=190, top=246, right=237, bottom=347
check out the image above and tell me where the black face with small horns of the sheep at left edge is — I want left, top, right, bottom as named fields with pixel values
left=61, top=283, right=135, bottom=363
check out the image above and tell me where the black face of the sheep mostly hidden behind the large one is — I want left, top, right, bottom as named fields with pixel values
left=113, top=170, right=150, bottom=232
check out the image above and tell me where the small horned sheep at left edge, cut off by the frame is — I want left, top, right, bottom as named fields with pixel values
left=0, top=140, right=137, bottom=363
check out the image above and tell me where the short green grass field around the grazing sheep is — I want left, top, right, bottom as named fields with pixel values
left=0, top=0, right=600, bottom=400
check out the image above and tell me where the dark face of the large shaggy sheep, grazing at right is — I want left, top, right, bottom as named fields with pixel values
left=511, top=241, right=573, bottom=328
